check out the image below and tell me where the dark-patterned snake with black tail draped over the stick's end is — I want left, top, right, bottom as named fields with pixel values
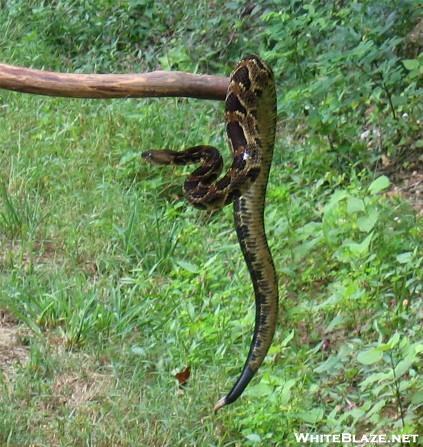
left=142, top=55, right=278, bottom=412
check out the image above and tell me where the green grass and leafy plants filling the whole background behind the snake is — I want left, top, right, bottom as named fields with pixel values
left=0, top=0, right=423, bottom=446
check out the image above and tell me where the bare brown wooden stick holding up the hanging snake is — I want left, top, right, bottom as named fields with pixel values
left=0, top=64, right=229, bottom=101
